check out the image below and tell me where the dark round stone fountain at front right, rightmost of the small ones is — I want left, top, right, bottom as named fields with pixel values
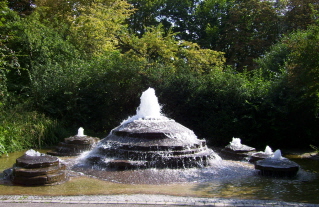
left=255, top=150, right=299, bottom=177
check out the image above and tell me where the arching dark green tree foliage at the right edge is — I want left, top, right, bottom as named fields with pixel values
left=257, top=22, right=319, bottom=107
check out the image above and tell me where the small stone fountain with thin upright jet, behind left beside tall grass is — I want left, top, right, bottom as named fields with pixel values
left=47, top=127, right=100, bottom=156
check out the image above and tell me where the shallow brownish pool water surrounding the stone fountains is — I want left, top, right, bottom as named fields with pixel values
left=0, top=152, right=319, bottom=204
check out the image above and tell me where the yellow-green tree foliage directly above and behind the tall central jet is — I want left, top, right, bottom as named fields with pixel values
left=118, top=25, right=225, bottom=74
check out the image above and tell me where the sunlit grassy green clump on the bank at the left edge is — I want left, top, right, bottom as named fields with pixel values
left=0, top=107, right=68, bottom=156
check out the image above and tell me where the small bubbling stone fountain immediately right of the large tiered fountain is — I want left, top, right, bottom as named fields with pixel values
left=221, top=137, right=256, bottom=160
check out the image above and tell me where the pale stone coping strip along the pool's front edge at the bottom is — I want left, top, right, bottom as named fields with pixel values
left=0, top=194, right=319, bottom=207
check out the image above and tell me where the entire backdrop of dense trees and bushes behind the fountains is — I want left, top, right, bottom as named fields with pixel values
left=0, top=0, right=319, bottom=154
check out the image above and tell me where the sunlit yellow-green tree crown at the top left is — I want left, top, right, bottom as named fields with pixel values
left=34, top=0, right=134, bottom=57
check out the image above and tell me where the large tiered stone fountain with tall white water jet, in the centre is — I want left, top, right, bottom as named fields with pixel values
left=85, top=88, right=218, bottom=169
